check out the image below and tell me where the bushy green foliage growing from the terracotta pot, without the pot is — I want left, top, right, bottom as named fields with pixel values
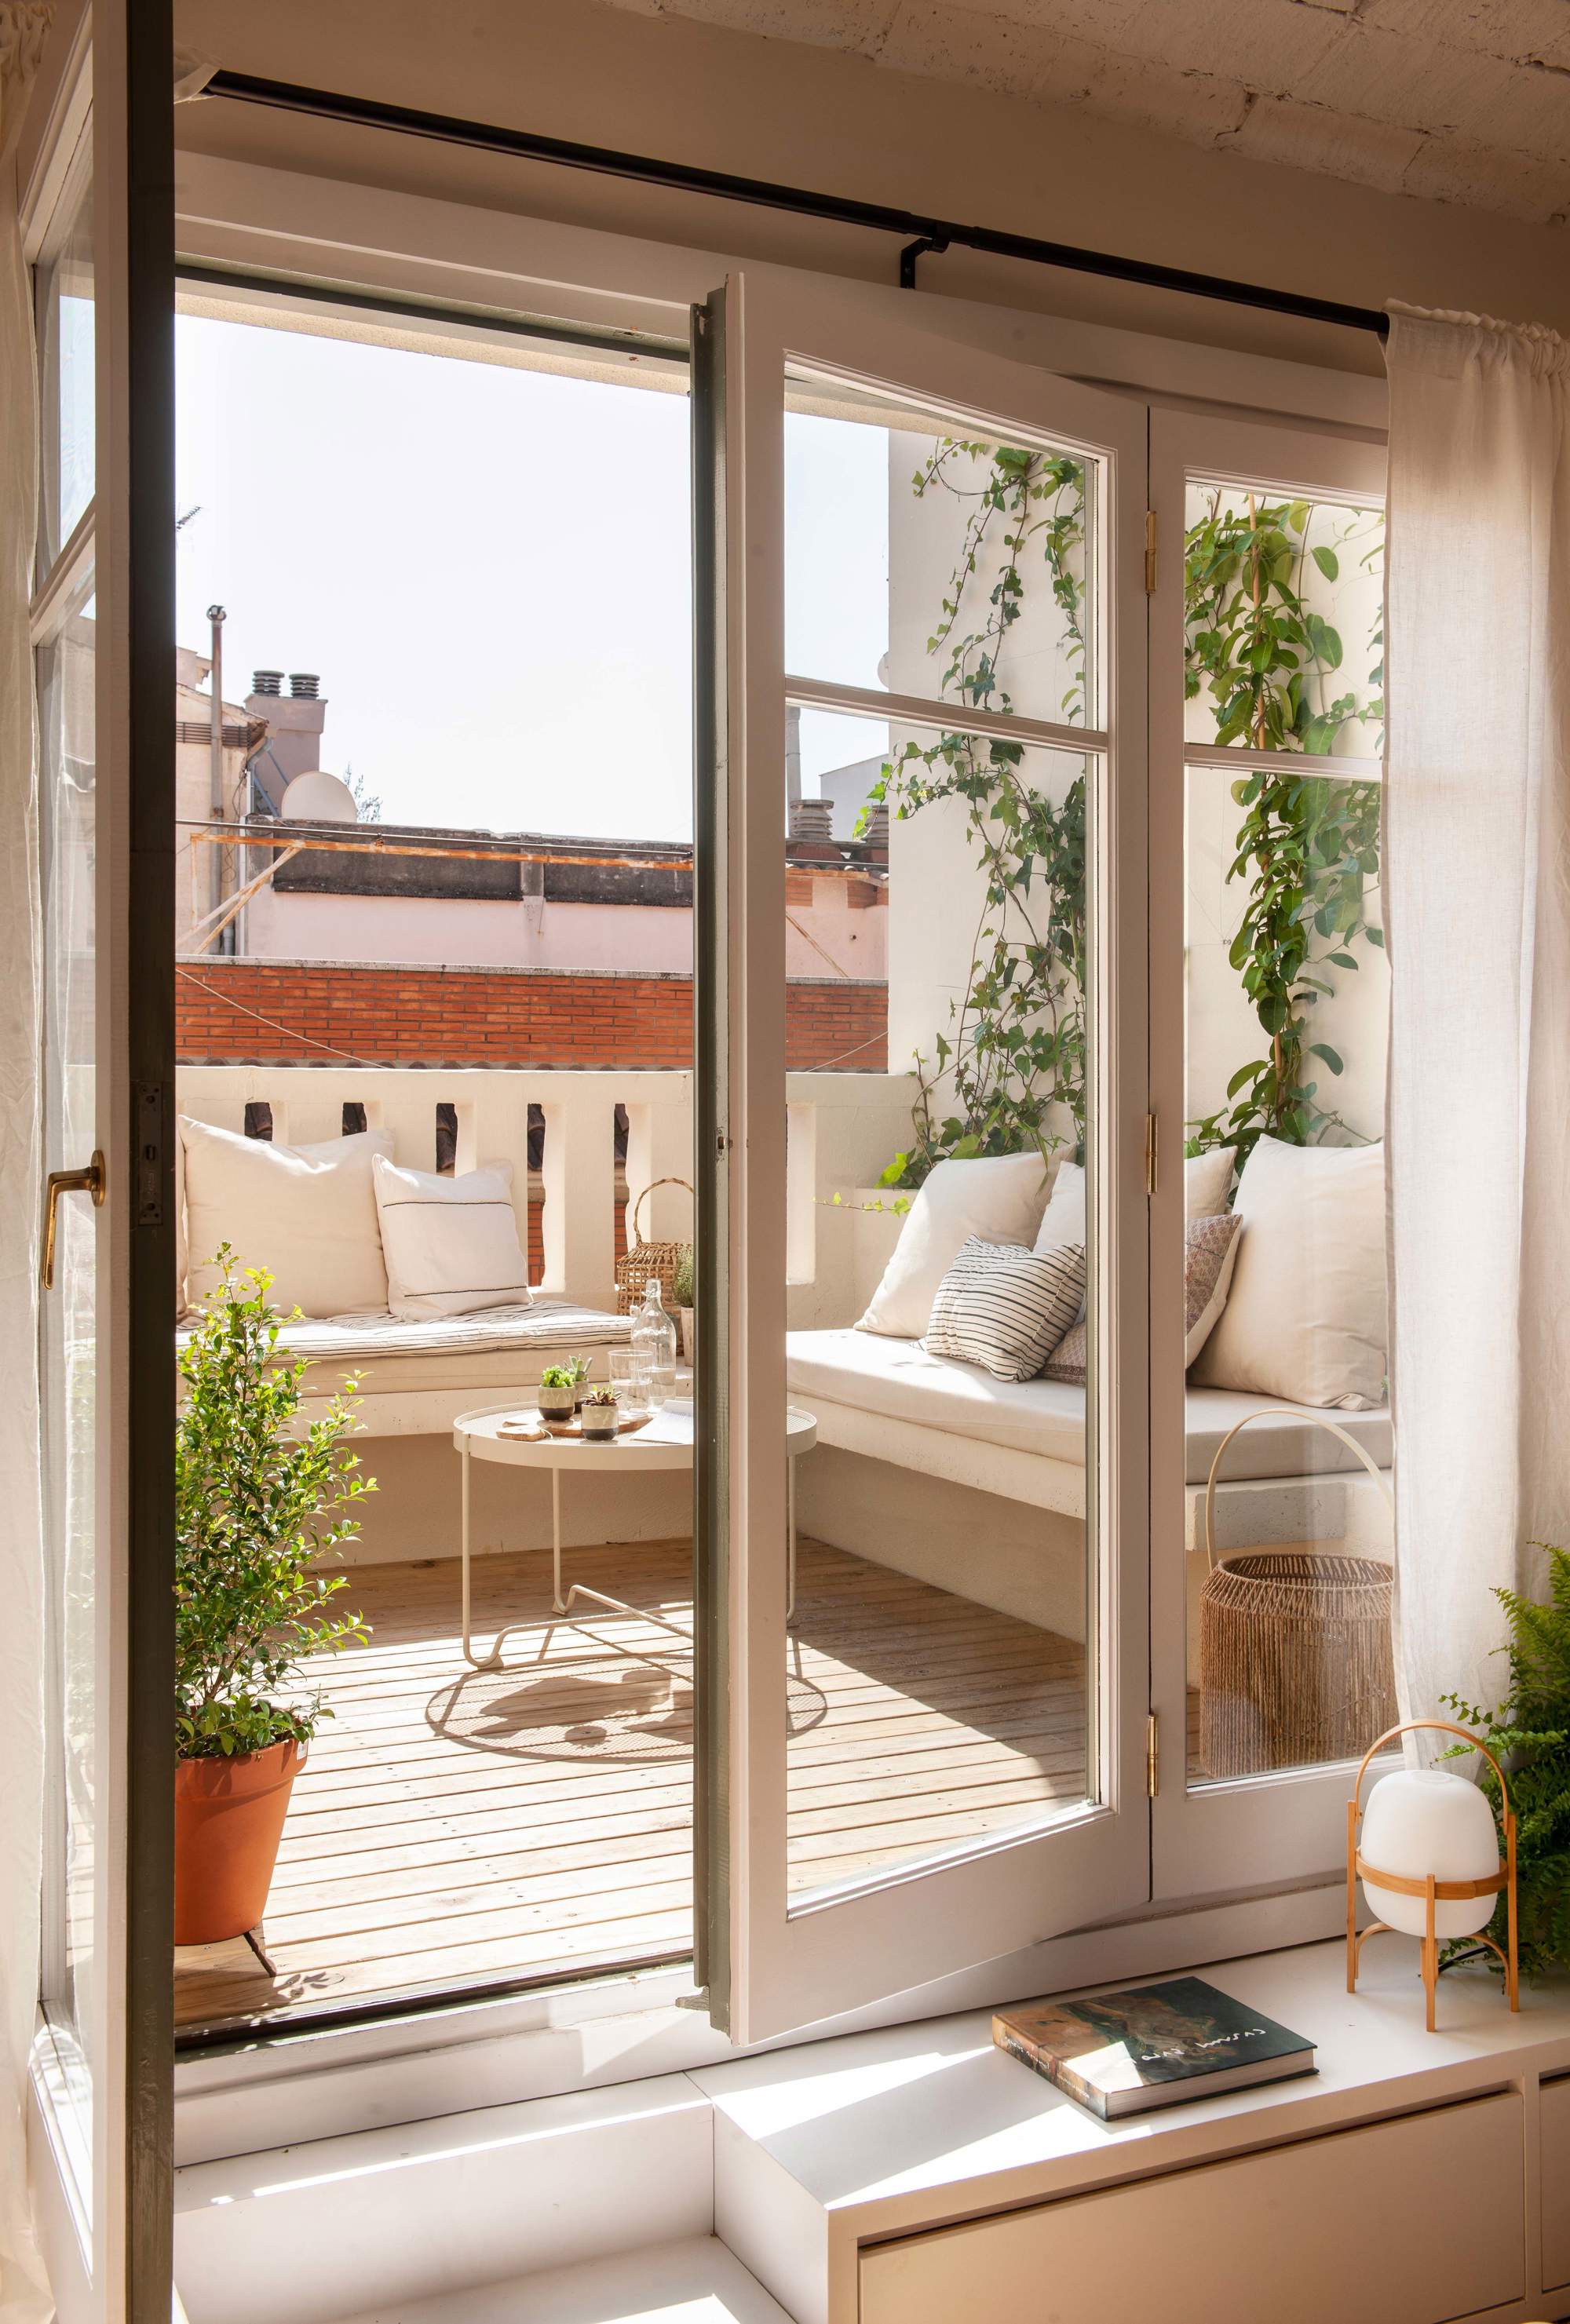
left=174, top=1243, right=377, bottom=1759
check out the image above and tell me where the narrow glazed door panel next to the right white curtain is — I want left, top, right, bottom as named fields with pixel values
left=1152, top=411, right=1393, bottom=1899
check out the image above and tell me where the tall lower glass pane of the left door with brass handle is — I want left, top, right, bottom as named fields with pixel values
left=37, top=571, right=97, bottom=2056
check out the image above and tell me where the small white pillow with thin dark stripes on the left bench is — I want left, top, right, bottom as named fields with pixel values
left=374, top=1155, right=531, bottom=1318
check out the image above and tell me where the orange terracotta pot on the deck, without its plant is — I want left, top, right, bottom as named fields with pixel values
left=174, top=1741, right=305, bottom=1945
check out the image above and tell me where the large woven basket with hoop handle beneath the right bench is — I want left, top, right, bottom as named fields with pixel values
left=1200, top=1413, right=1398, bottom=1780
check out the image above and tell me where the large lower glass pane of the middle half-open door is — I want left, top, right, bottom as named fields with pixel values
left=784, top=709, right=1100, bottom=1896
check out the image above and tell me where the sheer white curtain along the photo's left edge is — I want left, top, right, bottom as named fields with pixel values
left=0, top=0, right=51, bottom=2324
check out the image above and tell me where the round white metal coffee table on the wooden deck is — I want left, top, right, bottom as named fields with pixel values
left=454, top=1397, right=819, bottom=1671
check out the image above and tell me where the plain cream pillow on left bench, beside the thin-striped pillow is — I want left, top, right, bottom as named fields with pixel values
left=179, top=1113, right=393, bottom=1315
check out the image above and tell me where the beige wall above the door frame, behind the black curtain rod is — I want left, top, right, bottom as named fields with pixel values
left=174, top=0, right=1570, bottom=372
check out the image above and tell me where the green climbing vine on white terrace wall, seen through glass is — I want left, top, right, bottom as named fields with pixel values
left=867, top=440, right=1384, bottom=1188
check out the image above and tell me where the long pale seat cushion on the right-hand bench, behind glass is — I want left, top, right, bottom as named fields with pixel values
left=786, top=1332, right=1391, bottom=1485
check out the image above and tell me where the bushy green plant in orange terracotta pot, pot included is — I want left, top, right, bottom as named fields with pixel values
left=174, top=1246, right=374, bottom=1945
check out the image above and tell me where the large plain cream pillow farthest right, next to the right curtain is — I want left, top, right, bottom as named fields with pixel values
left=1191, top=1139, right=1386, bottom=1413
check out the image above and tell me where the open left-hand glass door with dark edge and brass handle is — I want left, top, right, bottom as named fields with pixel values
left=21, top=0, right=174, bottom=2324
